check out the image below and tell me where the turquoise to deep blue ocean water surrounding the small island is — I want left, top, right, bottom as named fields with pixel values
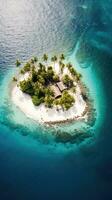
left=0, top=0, right=112, bottom=200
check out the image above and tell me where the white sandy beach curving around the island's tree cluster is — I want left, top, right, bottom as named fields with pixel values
left=11, top=65, right=86, bottom=123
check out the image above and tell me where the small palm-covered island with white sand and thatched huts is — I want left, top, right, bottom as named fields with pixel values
left=11, top=54, right=89, bottom=124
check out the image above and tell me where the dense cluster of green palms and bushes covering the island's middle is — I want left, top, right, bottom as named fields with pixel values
left=16, top=54, right=81, bottom=110
